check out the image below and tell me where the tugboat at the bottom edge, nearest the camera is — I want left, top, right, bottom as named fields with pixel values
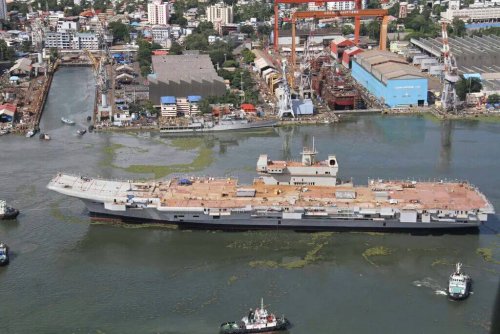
left=220, top=299, right=290, bottom=334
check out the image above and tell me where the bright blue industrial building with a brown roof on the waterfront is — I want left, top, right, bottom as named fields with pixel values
left=352, top=50, right=428, bottom=108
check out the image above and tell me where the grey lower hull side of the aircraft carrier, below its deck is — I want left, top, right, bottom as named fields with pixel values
left=83, top=200, right=481, bottom=232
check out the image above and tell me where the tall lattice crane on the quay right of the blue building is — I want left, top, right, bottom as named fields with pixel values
left=441, top=19, right=459, bottom=112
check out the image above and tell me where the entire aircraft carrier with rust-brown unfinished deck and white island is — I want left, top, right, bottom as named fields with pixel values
left=47, top=144, right=495, bottom=231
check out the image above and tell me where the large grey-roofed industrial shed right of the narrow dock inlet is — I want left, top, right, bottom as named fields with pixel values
left=148, top=54, right=226, bottom=106
